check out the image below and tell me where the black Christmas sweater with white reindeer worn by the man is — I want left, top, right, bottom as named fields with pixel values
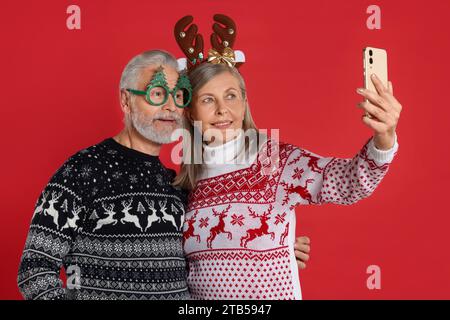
left=18, top=138, right=189, bottom=299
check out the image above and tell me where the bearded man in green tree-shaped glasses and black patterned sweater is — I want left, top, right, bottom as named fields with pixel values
left=18, top=50, right=309, bottom=299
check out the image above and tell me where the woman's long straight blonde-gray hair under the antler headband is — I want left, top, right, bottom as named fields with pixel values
left=173, top=63, right=258, bottom=190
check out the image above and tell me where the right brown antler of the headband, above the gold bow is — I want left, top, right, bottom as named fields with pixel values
left=211, top=14, right=236, bottom=53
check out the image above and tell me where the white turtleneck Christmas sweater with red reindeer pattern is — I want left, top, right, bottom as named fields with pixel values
left=183, top=134, right=398, bottom=299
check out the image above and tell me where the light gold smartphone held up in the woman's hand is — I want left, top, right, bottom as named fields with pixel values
left=363, top=47, right=388, bottom=118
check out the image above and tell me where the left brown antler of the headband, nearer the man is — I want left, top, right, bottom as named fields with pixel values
left=174, top=16, right=203, bottom=69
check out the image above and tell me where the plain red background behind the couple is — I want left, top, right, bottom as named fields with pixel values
left=0, top=0, right=450, bottom=299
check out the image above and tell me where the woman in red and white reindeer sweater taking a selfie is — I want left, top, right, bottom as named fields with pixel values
left=175, top=15, right=401, bottom=299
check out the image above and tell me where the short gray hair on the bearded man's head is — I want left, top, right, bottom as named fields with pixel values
left=119, top=50, right=178, bottom=90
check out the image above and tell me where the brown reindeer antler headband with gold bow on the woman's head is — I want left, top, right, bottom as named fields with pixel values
left=174, top=14, right=245, bottom=70
